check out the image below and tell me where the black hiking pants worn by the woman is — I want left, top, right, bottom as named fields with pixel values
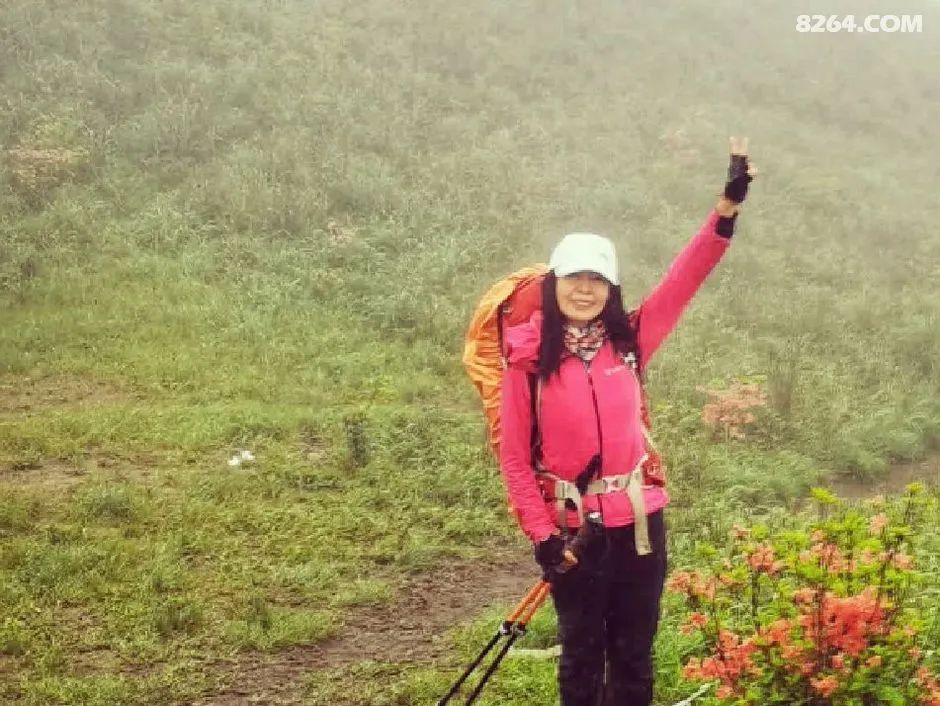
left=549, top=510, right=666, bottom=706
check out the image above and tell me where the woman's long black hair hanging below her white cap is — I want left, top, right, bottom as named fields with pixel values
left=539, top=272, right=640, bottom=381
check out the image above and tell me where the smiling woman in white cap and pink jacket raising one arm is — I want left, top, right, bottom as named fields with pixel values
left=500, top=138, right=756, bottom=706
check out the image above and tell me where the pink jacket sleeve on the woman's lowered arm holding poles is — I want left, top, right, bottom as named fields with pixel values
left=499, top=366, right=555, bottom=542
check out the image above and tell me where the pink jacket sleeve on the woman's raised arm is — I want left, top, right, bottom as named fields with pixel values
left=636, top=210, right=730, bottom=366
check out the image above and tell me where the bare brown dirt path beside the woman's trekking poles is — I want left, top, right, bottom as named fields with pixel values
left=195, top=551, right=538, bottom=706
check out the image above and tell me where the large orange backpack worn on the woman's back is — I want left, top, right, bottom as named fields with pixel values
left=463, top=264, right=666, bottom=486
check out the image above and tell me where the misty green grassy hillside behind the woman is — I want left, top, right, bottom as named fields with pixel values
left=0, top=0, right=940, bottom=704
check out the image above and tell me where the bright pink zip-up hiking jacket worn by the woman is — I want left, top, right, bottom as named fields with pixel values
left=500, top=211, right=729, bottom=542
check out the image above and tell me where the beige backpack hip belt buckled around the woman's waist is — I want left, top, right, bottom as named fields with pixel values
left=535, top=454, right=653, bottom=556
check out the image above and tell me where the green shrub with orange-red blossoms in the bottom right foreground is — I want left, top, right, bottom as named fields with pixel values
left=668, top=485, right=940, bottom=706
